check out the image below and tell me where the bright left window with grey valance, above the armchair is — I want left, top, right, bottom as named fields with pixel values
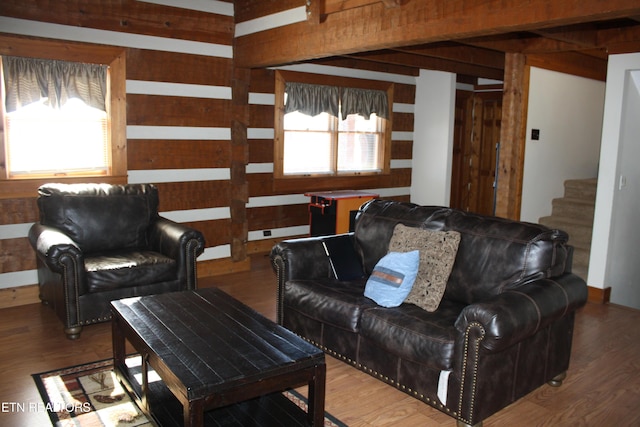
left=1, top=56, right=111, bottom=179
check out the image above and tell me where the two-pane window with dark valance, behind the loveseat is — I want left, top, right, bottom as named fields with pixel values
left=274, top=72, right=392, bottom=178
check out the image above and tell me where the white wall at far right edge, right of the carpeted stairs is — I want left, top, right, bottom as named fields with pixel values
left=588, top=53, right=640, bottom=308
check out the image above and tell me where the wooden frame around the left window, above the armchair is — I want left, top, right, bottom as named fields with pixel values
left=0, top=35, right=127, bottom=199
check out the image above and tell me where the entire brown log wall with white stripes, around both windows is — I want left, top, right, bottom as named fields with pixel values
left=0, top=0, right=415, bottom=308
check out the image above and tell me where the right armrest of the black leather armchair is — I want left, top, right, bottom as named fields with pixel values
left=149, top=217, right=205, bottom=289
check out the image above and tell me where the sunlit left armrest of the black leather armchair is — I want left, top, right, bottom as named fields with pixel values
left=29, top=223, right=84, bottom=274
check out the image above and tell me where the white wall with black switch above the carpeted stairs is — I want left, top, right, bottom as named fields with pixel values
left=520, top=67, right=605, bottom=222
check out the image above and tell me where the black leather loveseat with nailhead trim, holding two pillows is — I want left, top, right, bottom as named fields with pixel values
left=271, top=200, right=587, bottom=426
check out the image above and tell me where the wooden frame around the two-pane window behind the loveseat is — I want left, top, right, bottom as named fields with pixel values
left=273, top=70, right=394, bottom=182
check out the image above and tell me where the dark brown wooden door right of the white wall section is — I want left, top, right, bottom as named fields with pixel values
left=451, top=91, right=502, bottom=215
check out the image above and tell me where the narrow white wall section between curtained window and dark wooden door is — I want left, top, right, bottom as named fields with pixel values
left=411, top=70, right=456, bottom=206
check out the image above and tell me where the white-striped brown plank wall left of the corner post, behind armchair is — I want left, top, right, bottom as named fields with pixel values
left=0, top=0, right=238, bottom=307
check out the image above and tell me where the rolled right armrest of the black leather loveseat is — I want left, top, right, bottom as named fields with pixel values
left=455, top=273, right=587, bottom=352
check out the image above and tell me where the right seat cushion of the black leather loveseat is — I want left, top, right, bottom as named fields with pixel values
left=360, top=300, right=464, bottom=370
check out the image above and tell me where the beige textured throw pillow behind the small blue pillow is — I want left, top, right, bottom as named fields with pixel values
left=389, top=224, right=460, bottom=311
